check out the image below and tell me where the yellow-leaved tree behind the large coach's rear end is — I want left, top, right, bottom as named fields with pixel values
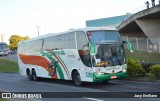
left=9, top=35, right=29, bottom=50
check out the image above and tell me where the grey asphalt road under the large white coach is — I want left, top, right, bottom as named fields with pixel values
left=0, top=73, right=160, bottom=101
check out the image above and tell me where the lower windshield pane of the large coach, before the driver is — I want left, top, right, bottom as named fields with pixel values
left=92, top=44, right=125, bottom=67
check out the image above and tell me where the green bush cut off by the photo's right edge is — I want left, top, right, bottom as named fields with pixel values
left=150, top=65, right=160, bottom=79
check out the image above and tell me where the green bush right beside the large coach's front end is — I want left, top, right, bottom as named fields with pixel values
left=127, top=58, right=145, bottom=76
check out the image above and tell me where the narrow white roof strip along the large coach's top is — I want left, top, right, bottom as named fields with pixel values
left=20, top=27, right=117, bottom=43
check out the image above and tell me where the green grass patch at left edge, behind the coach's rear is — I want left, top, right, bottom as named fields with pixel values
left=0, top=58, right=19, bottom=73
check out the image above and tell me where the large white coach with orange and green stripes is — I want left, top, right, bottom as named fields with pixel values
left=17, top=27, right=133, bottom=86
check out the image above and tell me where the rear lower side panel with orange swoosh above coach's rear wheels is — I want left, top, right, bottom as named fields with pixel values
left=18, top=53, right=51, bottom=78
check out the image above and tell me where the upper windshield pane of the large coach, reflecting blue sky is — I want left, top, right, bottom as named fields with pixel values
left=87, top=30, right=120, bottom=44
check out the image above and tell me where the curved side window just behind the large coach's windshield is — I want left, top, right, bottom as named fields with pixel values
left=76, top=31, right=91, bottom=67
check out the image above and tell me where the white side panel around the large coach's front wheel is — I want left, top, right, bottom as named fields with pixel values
left=64, top=49, right=93, bottom=82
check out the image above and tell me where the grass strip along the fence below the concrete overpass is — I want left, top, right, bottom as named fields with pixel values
left=126, top=50, right=160, bottom=62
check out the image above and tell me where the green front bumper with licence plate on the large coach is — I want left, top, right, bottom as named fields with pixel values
left=93, top=72, right=127, bottom=82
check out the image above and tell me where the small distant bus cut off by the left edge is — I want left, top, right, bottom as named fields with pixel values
left=0, top=42, right=9, bottom=56
